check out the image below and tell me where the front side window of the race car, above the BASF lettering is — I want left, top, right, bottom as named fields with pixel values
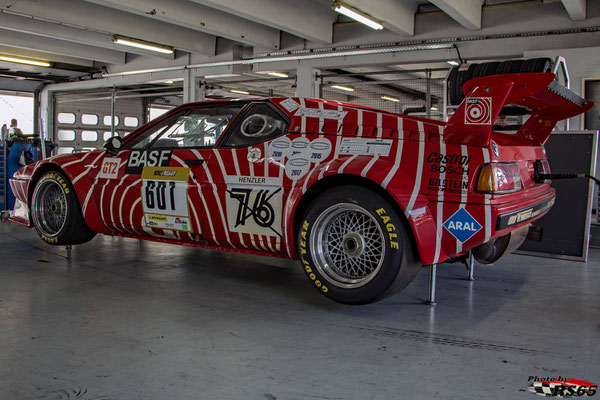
left=127, top=104, right=244, bottom=149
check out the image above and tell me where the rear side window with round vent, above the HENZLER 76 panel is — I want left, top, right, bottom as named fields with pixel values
left=223, top=103, right=290, bottom=147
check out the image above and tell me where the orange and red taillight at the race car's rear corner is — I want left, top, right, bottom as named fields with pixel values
left=477, top=163, right=523, bottom=194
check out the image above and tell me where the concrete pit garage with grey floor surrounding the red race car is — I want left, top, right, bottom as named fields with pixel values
left=0, top=0, right=600, bottom=400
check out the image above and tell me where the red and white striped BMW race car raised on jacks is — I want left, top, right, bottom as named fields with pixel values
left=10, top=73, right=593, bottom=304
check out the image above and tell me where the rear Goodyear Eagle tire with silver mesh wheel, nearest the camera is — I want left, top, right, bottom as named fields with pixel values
left=298, top=185, right=421, bottom=304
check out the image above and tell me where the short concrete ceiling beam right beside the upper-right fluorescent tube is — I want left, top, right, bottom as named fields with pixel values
left=346, top=0, right=418, bottom=36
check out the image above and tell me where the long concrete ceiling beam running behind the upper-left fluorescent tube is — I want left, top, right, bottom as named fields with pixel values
left=0, top=11, right=174, bottom=58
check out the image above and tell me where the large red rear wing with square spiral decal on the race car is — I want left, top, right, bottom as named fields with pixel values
left=444, top=73, right=594, bottom=147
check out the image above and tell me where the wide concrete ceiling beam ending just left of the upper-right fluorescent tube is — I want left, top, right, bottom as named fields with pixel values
left=191, top=0, right=335, bottom=44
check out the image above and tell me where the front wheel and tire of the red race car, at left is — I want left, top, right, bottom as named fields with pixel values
left=31, top=171, right=96, bottom=245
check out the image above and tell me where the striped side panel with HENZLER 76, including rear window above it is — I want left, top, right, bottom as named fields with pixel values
left=200, top=102, right=289, bottom=252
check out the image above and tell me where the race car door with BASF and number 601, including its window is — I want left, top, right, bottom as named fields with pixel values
left=95, top=104, right=243, bottom=241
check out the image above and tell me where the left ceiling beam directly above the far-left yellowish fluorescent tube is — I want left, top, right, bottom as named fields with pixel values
left=0, top=29, right=125, bottom=64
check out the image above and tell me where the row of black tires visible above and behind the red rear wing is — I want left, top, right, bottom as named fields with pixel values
left=448, top=58, right=554, bottom=106
